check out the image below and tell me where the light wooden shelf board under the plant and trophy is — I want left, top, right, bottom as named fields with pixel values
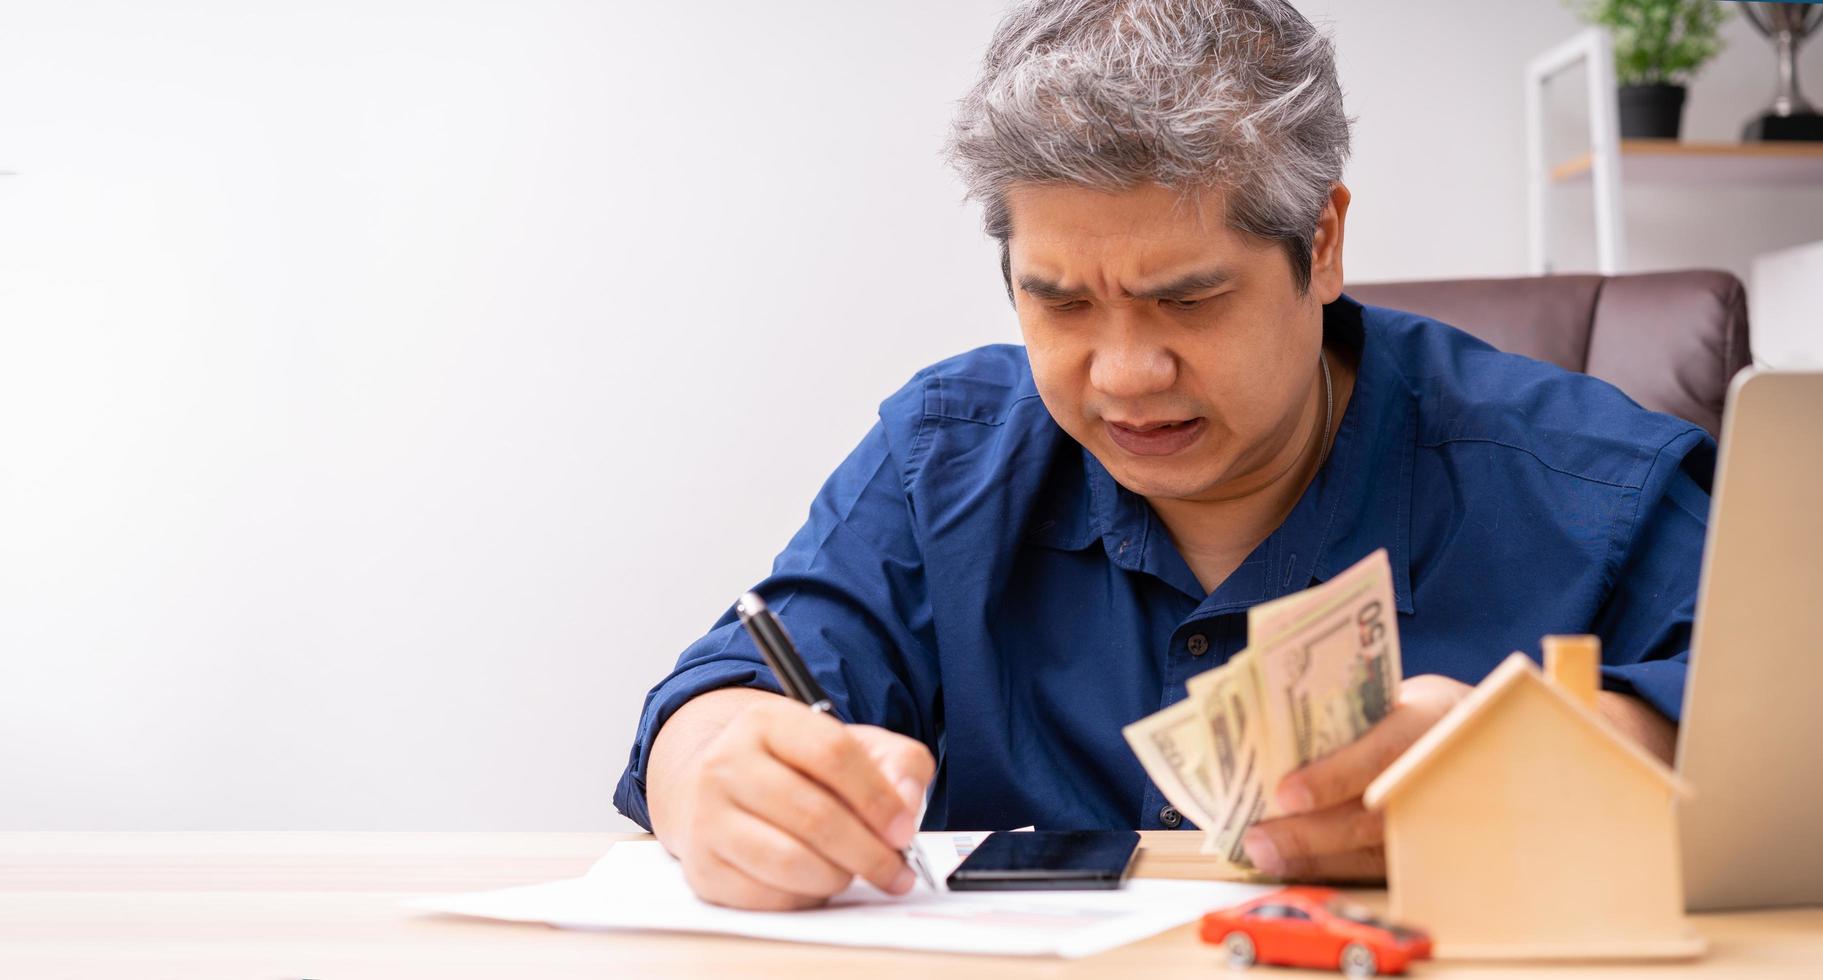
left=1551, top=140, right=1823, bottom=186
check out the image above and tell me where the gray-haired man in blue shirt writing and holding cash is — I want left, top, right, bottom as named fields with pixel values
left=616, top=0, right=1714, bottom=909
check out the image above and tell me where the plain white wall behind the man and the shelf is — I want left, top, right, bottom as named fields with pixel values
left=0, top=0, right=1823, bottom=829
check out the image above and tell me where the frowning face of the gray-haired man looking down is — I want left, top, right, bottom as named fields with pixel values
left=1006, top=184, right=1349, bottom=501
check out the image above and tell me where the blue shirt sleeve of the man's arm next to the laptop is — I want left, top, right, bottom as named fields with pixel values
left=1595, top=430, right=1715, bottom=721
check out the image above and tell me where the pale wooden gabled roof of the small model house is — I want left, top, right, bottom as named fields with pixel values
left=1362, top=654, right=1690, bottom=809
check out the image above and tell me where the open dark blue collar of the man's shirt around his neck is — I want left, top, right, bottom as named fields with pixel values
left=1026, top=293, right=1416, bottom=616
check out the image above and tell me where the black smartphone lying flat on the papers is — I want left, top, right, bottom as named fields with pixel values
left=948, top=831, right=1139, bottom=891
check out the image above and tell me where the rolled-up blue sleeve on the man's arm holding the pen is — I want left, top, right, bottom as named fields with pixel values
left=614, top=399, right=937, bottom=829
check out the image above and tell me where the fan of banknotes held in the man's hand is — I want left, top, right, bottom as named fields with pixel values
left=1121, top=548, right=1402, bottom=874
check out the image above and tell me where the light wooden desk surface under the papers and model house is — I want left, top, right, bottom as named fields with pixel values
left=0, top=832, right=1823, bottom=980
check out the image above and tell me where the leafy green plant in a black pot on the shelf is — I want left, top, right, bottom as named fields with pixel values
left=1566, top=0, right=1728, bottom=140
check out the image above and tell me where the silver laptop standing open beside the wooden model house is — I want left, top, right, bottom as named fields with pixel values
left=1677, top=368, right=1823, bottom=911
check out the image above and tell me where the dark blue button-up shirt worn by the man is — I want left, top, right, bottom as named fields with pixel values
left=614, top=295, right=1715, bottom=829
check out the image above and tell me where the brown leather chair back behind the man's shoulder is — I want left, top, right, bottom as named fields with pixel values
left=1347, top=270, right=1750, bottom=435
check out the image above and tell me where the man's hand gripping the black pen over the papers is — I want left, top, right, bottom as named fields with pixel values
left=647, top=690, right=935, bottom=909
